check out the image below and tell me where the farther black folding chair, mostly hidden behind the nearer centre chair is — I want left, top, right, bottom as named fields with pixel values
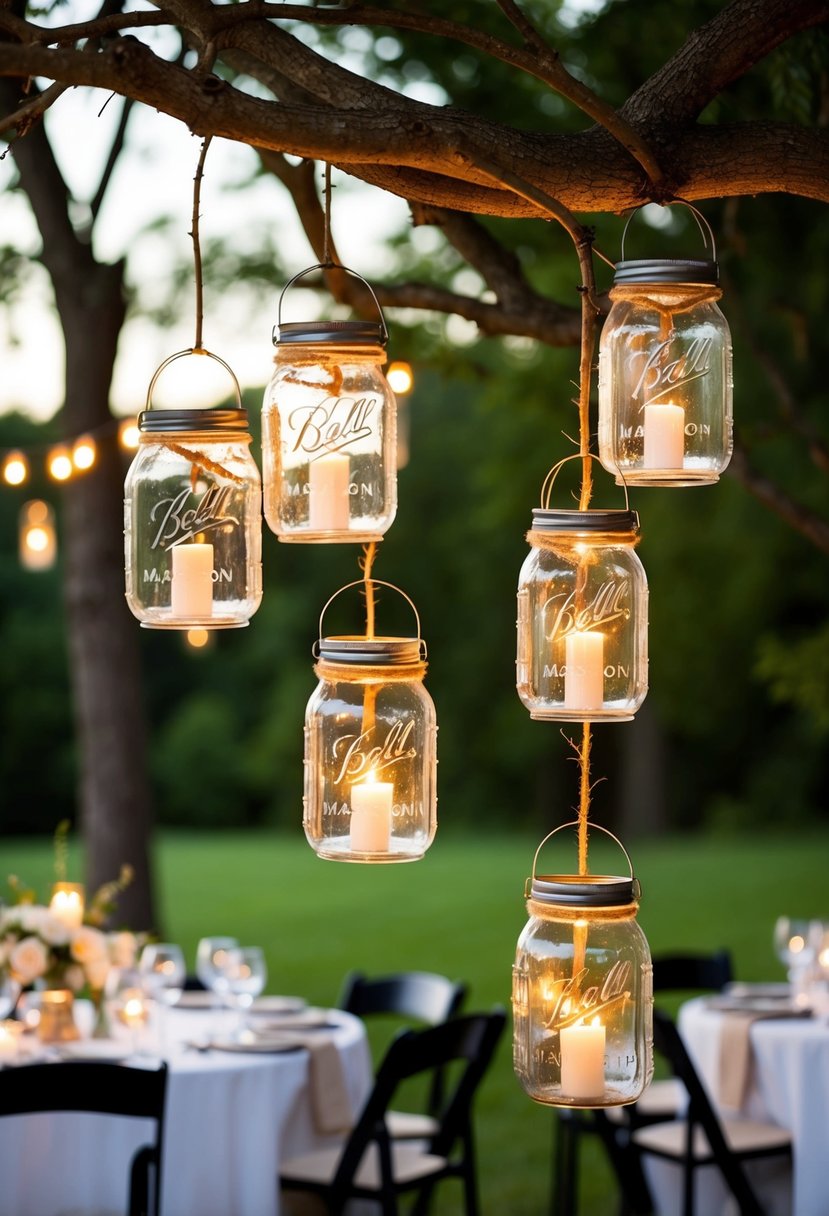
left=339, top=972, right=467, bottom=1139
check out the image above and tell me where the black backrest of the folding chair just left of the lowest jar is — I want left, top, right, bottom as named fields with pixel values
left=334, top=1007, right=507, bottom=1186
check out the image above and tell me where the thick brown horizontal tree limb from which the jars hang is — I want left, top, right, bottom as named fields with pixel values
left=0, top=40, right=829, bottom=209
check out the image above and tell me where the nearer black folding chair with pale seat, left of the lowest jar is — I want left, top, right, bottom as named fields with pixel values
left=280, top=1008, right=506, bottom=1216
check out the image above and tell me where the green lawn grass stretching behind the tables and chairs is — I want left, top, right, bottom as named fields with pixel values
left=0, top=831, right=829, bottom=1216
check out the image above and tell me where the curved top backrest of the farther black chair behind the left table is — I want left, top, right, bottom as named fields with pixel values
left=339, top=972, right=467, bottom=1026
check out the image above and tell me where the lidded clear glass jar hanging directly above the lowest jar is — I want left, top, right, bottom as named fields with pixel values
left=517, top=508, right=648, bottom=722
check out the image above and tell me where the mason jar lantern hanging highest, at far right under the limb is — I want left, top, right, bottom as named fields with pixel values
left=599, top=203, right=733, bottom=485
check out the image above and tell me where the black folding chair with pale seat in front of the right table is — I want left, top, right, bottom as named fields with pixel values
left=632, top=1010, right=791, bottom=1216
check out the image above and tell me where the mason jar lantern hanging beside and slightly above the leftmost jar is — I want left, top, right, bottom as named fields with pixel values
left=263, top=266, right=397, bottom=544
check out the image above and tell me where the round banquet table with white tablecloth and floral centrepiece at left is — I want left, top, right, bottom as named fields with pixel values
left=0, top=1009, right=372, bottom=1216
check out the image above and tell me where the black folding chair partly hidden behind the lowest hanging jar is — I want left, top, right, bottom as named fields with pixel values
left=551, top=950, right=733, bottom=1216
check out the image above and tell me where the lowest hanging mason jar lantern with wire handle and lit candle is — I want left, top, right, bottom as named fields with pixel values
left=513, top=823, right=653, bottom=1107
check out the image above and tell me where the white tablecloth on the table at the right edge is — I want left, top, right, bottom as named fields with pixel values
left=679, top=997, right=829, bottom=1216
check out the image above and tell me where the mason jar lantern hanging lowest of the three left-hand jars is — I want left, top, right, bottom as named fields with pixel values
left=304, top=580, right=438, bottom=862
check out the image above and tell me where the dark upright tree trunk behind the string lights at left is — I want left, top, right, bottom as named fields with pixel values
left=57, top=265, right=154, bottom=929
